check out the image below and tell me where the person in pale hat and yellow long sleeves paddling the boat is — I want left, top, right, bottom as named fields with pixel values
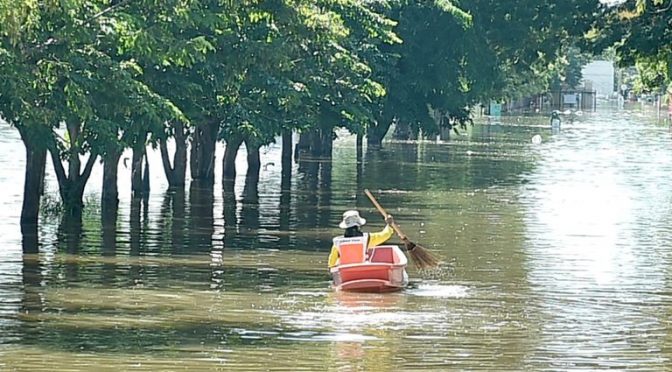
left=329, top=210, right=394, bottom=268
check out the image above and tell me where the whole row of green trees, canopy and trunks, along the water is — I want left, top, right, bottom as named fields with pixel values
left=0, top=0, right=671, bottom=234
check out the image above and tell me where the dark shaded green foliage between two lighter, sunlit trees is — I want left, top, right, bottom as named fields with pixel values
left=362, top=1, right=478, bottom=137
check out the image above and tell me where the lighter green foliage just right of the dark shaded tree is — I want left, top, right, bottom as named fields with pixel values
left=467, top=0, right=601, bottom=98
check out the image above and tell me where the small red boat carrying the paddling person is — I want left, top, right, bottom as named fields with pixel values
left=331, top=242, right=408, bottom=292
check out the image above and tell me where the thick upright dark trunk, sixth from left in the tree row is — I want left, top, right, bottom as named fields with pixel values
left=190, top=121, right=219, bottom=184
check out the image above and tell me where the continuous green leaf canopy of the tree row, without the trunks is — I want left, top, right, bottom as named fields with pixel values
left=0, top=0, right=608, bottom=154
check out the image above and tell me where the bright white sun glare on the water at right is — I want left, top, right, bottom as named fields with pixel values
left=524, top=104, right=672, bottom=369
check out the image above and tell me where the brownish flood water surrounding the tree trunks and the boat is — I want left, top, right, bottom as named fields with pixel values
left=0, top=104, right=672, bottom=371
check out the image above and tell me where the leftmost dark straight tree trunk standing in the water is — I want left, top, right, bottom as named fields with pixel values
left=21, top=139, right=47, bottom=234
